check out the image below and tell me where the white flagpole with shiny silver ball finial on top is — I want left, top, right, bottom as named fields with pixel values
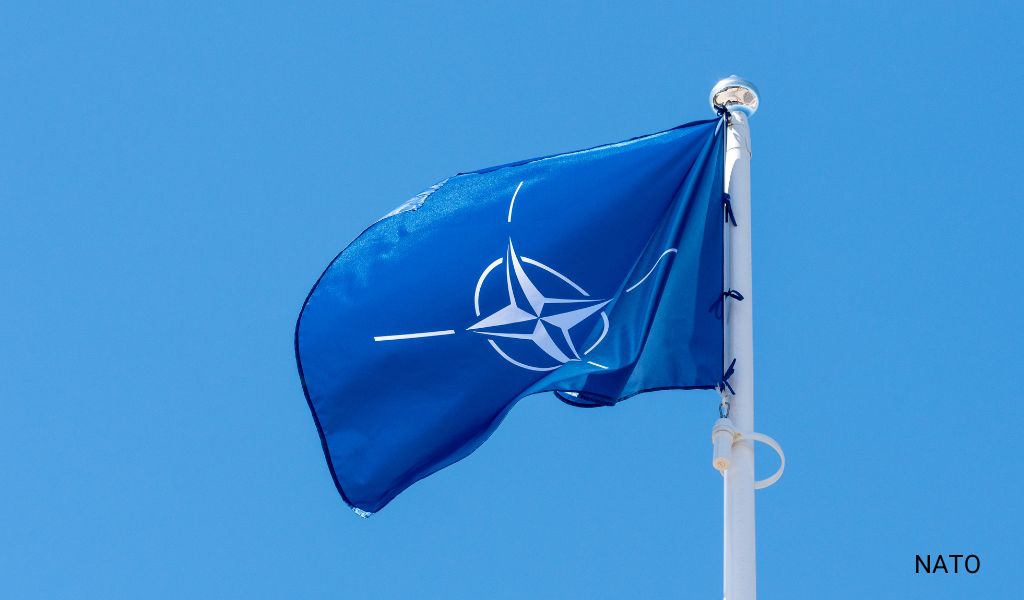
left=711, top=76, right=759, bottom=600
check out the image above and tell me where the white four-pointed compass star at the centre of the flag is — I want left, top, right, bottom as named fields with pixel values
left=469, top=240, right=608, bottom=362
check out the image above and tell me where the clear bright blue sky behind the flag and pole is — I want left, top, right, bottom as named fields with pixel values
left=0, top=2, right=1024, bottom=599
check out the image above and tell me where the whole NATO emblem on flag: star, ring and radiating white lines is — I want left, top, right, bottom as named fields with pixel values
left=374, top=181, right=676, bottom=371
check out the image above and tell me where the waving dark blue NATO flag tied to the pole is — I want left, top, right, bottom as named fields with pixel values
left=295, top=120, right=724, bottom=516
